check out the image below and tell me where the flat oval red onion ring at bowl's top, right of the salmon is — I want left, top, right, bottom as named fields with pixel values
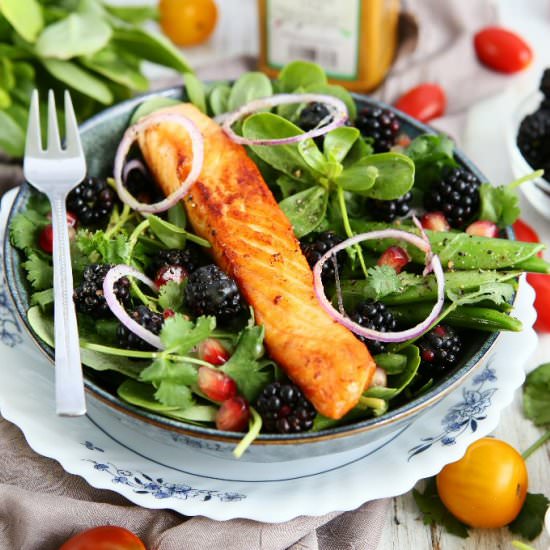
left=222, top=94, right=348, bottom=145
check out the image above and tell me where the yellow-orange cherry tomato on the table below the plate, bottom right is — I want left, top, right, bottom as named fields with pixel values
left=436, top=437, right=527, bottom=528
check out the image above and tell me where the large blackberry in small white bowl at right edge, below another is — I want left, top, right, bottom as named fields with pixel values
left=517, top=108, right=550, bottom=169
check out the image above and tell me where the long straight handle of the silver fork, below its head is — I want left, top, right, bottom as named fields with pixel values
left=50, top=195, right=86, bottom=416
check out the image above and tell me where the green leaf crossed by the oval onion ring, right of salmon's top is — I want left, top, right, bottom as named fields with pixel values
left=242, top=113, right=318, bottom=183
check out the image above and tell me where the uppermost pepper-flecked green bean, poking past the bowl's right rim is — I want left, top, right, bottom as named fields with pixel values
left=352, top=220, right=550, bottom=273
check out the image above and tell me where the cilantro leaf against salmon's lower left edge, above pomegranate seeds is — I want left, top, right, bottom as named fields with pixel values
left=220, top=325, right=269, bottom=401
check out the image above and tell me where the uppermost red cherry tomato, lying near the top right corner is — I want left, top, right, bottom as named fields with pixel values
left=474, top=27, right=533, bottom=73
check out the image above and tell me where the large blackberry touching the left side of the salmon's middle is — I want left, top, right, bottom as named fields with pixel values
left=184, top=264, right=244, bottom=324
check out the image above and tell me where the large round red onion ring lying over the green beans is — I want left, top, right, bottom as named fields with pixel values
left=313, top=229, right=445, bottom=342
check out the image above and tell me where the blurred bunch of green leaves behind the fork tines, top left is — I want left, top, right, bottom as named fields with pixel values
left=0, top=0, right=191, bottom=157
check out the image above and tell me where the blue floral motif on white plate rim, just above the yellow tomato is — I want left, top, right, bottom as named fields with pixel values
left=408, top=360, right=497, bottom=460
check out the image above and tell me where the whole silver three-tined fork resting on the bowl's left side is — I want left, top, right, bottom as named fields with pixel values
left=23, top=90, right=86, bottom=416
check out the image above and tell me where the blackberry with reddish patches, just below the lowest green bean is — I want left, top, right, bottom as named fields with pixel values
left=418, top=324, right=462, bottom=376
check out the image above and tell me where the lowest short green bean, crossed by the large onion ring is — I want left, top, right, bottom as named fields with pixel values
left=388, top=303, right=522, bottom=332
